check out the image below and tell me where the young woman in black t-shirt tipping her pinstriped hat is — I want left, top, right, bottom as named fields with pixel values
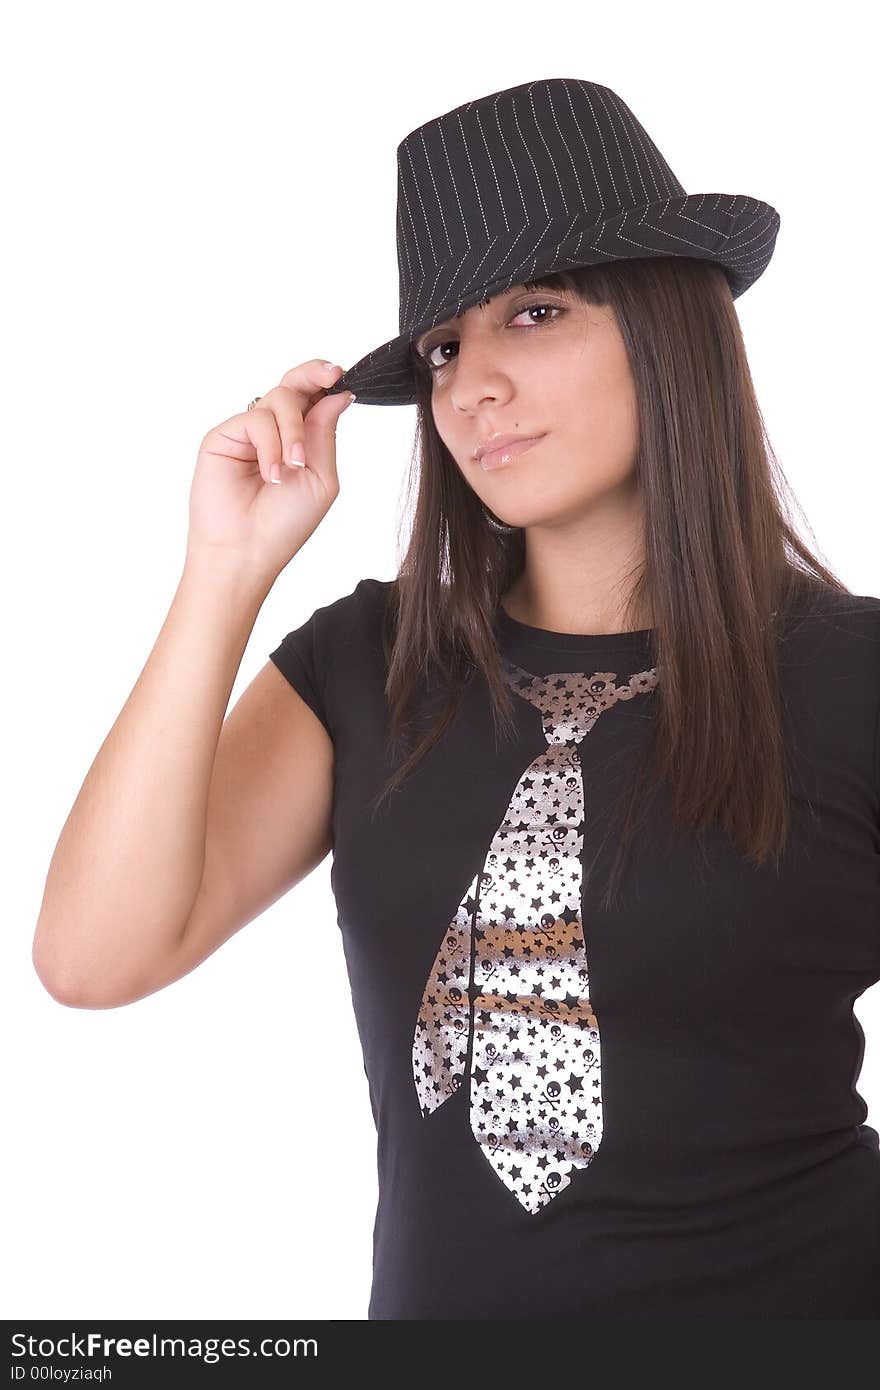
left=35, top=79, right=880, bottom=1319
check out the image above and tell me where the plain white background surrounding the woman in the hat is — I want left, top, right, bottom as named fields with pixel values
left=0, top=0, right=880, bottom=1319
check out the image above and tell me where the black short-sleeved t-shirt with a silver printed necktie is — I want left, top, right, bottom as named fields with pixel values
left=271, top=578, right=880, bottom=1319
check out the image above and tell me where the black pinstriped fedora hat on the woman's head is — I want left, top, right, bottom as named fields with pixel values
left=328, top=78, right=780, bottom=406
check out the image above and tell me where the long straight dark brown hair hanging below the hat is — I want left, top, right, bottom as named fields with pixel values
left=373, top=257, right=851, bottom=906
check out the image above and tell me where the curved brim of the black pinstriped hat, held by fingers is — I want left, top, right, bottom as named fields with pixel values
left=328, top=193, right=780, bottom=406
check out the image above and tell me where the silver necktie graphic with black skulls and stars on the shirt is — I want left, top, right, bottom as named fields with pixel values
left=413, top=662, right=658, bottom=1215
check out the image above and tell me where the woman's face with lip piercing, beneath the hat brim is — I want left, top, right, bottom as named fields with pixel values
left=413, top=285, right=638, bottom=527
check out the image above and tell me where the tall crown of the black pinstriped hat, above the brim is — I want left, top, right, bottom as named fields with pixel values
left=398, top=78, right=684, bottom=332
